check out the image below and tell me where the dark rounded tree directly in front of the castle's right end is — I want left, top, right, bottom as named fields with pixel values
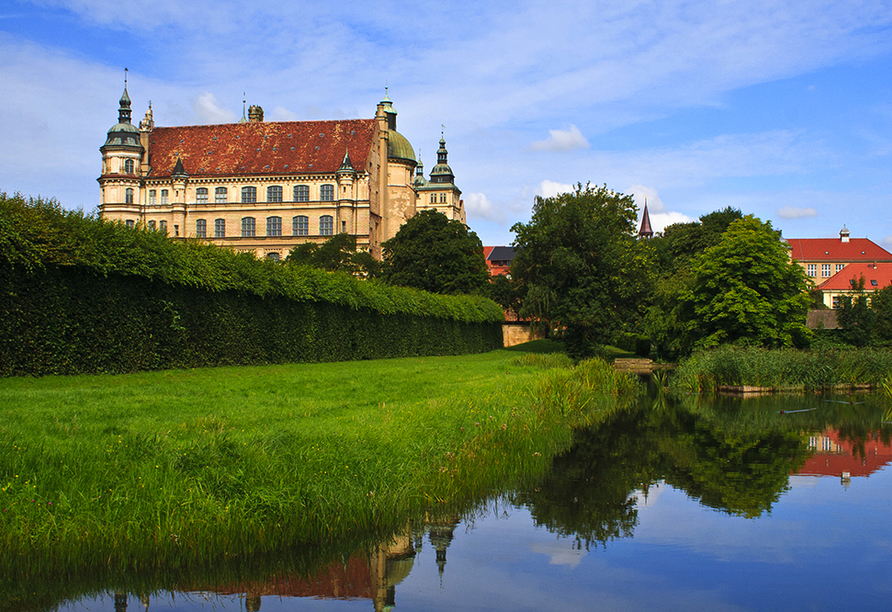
left=381, top=210, right=489, bottom=294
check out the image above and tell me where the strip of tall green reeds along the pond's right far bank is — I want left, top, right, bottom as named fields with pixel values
left=672, top=346, right=892, bottom=392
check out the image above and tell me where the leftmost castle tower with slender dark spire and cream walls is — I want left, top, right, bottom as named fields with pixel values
left=97, top=79, right=145, bottom=226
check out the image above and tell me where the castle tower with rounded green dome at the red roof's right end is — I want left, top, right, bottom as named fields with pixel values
left=376, top=92, right=417, bottom=240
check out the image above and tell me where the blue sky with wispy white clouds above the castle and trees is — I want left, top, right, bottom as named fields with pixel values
left=0, top=0, right=892, bottom=249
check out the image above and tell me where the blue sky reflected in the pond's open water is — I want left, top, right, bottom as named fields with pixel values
left=62, top=468, right=892, bottom=612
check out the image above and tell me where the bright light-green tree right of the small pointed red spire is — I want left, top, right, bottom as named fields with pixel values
left=679, top=215, right=810, bottom=348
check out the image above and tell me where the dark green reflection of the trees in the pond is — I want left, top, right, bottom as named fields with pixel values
left=514, top=401, right=809, bottom=546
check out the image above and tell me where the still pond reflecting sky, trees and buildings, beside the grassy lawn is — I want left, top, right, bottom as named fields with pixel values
left=31, top=395, right=892, bottom=612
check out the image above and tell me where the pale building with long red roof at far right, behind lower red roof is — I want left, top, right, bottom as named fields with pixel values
left=787, top=227, right=892, bottom=290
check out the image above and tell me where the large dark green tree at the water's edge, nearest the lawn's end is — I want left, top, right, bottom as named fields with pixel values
left=511, top=184, right=648, bottom=358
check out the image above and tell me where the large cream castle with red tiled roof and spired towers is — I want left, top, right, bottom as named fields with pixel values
left=98, top=84, right=465, bottom=259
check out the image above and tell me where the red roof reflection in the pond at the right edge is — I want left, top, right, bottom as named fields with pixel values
left=797, top=429, right=892, bottom=486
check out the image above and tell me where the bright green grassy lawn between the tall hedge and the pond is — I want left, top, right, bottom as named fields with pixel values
left=0, top=342, right=634, bottom=583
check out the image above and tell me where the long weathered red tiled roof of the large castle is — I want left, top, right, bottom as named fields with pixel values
left=149, top=119, right=377, bottom=178
